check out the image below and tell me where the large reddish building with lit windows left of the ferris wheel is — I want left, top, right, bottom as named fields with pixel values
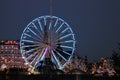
left=0, top=40, right=28, bottom=68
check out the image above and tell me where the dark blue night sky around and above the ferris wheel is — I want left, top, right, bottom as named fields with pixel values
left=0, top=0, right=120, bottom=60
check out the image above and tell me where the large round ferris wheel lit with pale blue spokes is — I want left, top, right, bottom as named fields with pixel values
left=20, top=16, right=75, bottom=69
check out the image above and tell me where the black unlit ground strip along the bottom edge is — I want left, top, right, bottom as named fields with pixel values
left=0, top=74, right=120, bottom=80
